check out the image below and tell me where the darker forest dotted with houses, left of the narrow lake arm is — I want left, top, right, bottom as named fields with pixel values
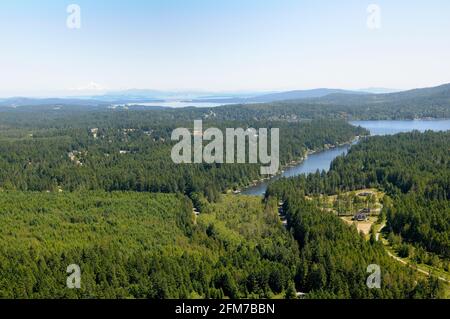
left=0, top=111, right=367, bottom=199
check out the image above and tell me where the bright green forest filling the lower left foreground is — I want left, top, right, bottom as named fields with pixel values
left=0, top=192, right=298, bottom=298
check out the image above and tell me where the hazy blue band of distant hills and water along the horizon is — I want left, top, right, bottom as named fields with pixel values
left=0, top=84, right=450, bottom=109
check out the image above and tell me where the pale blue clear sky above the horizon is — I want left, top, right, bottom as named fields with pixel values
left=0, top=0, right=450, bottom=97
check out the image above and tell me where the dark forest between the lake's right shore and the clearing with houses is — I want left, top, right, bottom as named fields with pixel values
left=268, top=132, right=450, bottom=259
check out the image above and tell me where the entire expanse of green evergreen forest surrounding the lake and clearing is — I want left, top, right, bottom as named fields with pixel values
left=0, top=105, right=450, bottom=298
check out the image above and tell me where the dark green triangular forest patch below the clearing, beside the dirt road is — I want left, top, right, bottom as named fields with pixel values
left=284, top=198, right=443, bottom=299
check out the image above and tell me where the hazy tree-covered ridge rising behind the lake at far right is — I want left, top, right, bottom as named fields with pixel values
left=217, top=84, right=450, bottom=121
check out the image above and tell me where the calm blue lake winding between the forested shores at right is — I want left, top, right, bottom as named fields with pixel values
left=242, top=120, right=450, bottom=196
